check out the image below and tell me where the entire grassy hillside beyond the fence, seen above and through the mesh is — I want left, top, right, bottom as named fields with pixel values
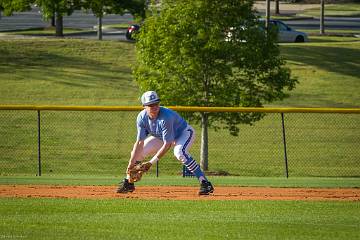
left=0, top=37, right=360, bottom=177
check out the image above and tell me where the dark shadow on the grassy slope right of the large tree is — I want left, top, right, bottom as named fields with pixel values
left=282, top=45, right=360, bottom=77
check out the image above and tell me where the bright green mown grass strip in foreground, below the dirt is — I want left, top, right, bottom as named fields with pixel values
left=0, top=198, right=360, bottom=240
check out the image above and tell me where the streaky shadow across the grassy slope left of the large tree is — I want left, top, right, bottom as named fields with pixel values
left=0, top=40, right=131, bottom=87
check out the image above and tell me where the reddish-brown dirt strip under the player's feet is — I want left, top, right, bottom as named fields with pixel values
left=0, top=185, right=360, bottom=201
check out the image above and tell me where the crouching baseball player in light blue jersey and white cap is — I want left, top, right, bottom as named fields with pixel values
left=117, top=91, right=214, bottom=195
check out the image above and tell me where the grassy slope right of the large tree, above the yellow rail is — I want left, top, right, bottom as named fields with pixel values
left=278, top=40, right=360, bottom=107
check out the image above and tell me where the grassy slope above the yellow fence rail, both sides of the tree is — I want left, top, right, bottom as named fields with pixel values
left=0, top=36, right=360, bottom=107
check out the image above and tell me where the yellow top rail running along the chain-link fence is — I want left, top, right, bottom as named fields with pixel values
left=0, top=105, right=360, bottom=114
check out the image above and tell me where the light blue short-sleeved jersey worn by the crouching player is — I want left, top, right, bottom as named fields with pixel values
left=136, top=107, right=187, bottom=142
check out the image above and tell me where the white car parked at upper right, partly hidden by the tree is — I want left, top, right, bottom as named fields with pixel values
left=261, top=20, right=309, bottom=42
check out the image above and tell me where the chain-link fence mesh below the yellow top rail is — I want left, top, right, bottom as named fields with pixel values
left=0, top=109, right=360, bottom=177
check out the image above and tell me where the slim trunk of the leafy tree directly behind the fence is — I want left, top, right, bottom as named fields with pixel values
left=200, top=113, right=209, bottom=171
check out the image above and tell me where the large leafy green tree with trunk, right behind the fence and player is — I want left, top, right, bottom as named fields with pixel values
left=134, top=0, right=296, bottom=170
